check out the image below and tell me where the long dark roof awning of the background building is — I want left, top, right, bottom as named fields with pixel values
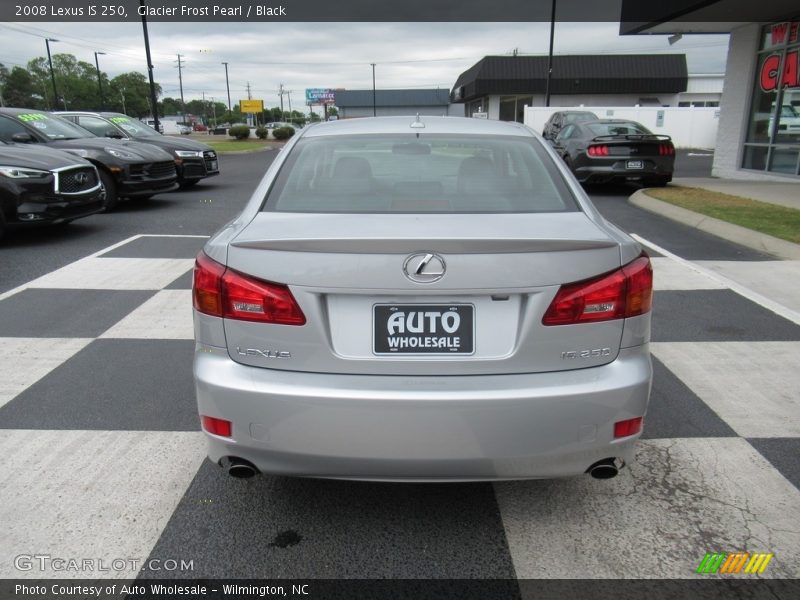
left=452, top=54, right=688, bottom=102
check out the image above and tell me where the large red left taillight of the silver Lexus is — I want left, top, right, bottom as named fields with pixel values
left=192, top=252, right=306, bottom=325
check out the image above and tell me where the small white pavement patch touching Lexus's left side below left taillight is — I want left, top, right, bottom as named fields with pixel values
left=100, top=290, right=194, bottom=340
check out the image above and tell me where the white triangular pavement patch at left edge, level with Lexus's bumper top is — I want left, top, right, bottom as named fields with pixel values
left=0, top=337, right=92, bottom=406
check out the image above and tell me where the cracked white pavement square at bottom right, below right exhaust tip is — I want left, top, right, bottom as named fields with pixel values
left=495, top=438, right=800, bottom=579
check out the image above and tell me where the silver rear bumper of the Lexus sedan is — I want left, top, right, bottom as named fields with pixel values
left=194, top=344, right=652, bottom=481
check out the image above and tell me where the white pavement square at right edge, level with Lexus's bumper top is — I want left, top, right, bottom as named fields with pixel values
left=650, top=342, right=800, bottom=437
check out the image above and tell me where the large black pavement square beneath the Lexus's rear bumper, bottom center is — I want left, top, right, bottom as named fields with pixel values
left=140, top=460, right=515, bottom=579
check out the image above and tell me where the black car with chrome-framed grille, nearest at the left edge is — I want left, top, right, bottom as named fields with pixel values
left=0, top=142, right=103, bottom=237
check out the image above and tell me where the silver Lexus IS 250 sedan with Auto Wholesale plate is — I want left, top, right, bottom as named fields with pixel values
left=193, top=117, right=652, bottom=481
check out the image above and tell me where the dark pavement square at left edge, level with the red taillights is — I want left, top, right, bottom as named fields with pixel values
left=0, top=288, right=155, bottom=338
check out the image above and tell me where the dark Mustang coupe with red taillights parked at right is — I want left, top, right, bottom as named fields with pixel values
left=552, top=119, right=675, bottom=187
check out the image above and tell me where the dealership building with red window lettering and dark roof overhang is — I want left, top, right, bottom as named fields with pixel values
left=620, top=0, right=800, bottom=179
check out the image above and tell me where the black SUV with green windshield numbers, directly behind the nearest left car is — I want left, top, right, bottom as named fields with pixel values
left=0, top=108, right=178, bottom=210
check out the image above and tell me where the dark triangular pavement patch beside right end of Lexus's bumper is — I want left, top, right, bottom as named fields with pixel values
left=642, top=357, right=738, bottom=439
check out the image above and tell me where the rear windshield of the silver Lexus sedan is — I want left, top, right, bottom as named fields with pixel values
left=264, top=133, right=578, bottom=213
